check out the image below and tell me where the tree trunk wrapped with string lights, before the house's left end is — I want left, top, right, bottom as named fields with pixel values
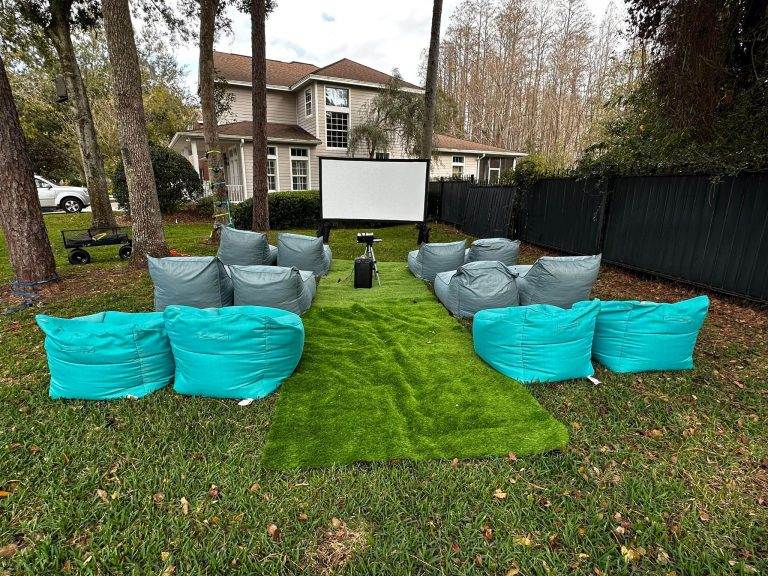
left=199, top=0, right=227, bottom=227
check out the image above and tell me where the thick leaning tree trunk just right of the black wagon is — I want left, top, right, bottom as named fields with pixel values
left=102, top=0, right=168, bottom=266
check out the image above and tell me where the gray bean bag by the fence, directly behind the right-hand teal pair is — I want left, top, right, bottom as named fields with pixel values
left=509, top=254, right=602, bottom=308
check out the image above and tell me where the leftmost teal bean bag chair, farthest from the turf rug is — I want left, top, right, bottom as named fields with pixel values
left=35, top=312, right=173, bottom=400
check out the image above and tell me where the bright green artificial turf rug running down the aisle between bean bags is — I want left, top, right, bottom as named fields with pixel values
left=263, top=261, right=568, bottom=469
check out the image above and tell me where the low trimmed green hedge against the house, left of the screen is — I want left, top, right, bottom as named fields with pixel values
left=231, top=190, right=320, bottom=230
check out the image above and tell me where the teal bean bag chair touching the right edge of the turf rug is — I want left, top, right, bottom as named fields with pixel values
left=472, top=300, right=600, bottom=383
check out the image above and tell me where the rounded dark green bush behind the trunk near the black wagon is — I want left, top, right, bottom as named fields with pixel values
left=112, top=142, right=203, bottom=213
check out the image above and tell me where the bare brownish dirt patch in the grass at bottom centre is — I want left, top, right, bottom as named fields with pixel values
left=305, top=518, right=369, bottom=574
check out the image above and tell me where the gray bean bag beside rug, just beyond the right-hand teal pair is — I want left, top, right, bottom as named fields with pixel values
left=435, top=261, right=520, bottom=318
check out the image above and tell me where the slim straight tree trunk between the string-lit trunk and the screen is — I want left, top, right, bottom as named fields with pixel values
left=251, top=0, right=269, bottom=232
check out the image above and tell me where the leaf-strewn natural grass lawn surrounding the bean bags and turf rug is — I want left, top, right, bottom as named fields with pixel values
left=0, top=215, right=768, bottom=575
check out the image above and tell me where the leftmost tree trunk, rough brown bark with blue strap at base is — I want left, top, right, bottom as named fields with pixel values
left=0, top=54, right=56, bottom=288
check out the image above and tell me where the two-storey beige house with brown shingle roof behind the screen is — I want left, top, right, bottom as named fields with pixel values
left=170, top=52, right=525, bottom=201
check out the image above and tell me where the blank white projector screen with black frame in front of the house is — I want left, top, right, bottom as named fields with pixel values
left=320, top=158, right=429, bottom=222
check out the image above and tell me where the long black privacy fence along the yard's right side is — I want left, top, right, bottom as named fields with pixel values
left=432, top=173, right=768, bottom=302
